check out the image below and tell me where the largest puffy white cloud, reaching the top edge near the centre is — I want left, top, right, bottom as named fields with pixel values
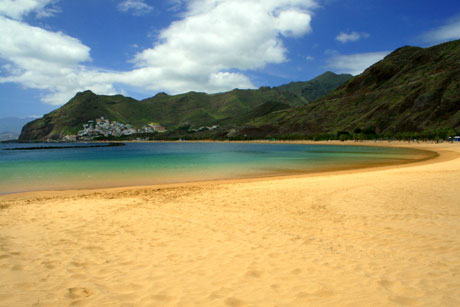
left=129, top=0, right=316, bottom=93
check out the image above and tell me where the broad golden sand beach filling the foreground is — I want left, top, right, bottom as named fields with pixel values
left=0, top=142, right=460, bottom=306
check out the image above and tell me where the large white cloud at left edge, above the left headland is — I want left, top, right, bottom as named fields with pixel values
left=0, top=16, right=115, bottom=105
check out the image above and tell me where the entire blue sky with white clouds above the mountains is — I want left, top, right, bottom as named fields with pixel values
left=0, top=0, right=460, bottom=117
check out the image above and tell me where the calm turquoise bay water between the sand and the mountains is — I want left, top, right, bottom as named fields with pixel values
left=0, top=143, right=419, bottom=194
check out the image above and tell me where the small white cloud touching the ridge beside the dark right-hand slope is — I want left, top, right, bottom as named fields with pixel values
left=328, top=51, right=390, bottom=75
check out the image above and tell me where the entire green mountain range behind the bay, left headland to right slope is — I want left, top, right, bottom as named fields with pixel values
left=20, top=40, right=460, bottom=140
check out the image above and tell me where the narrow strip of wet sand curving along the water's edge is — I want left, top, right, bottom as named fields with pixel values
left=0, top=140, right=446, bottom=201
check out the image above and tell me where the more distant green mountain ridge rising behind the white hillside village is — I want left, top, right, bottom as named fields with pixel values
left=16, top=72, right=352, bottom=140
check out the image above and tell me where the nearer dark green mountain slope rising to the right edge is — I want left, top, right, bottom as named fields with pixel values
left=236, top=40, right=460, bottom=138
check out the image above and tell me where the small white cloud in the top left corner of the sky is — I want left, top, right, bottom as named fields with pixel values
left=0, top=0, right=58, bottom=20
